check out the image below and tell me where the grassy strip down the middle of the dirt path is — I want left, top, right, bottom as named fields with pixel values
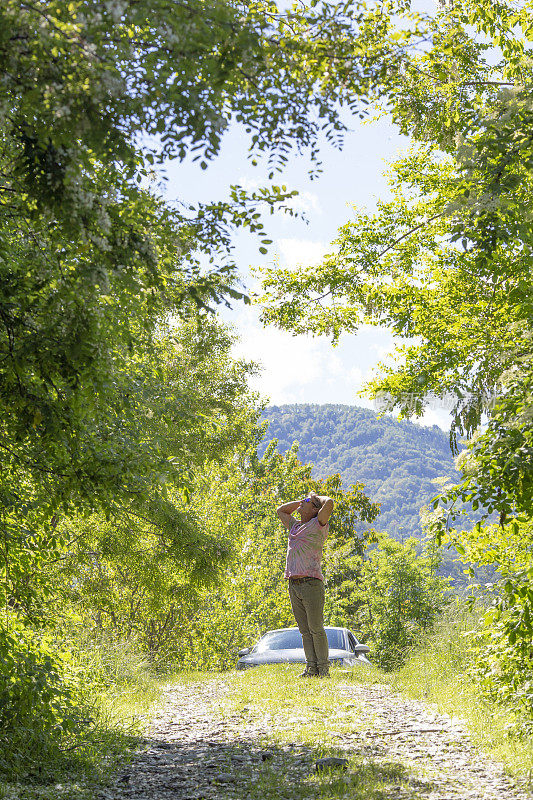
left=220, top=665, right=424, bottom=800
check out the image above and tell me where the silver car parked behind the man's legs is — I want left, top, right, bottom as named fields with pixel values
left=237, top=628, right=370, bottom=669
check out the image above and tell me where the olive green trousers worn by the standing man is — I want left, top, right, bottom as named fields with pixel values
left=289, top=578, right=329, bottom=675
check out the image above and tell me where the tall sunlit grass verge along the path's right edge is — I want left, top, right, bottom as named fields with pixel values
left=383, top=608, right=533, bottom=784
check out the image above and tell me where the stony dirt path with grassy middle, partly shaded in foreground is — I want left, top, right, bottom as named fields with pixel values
left=98, top=679, right=533, bottom=800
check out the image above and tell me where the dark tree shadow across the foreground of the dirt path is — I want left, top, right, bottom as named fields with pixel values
left=104, top=732, right=434, bottom=800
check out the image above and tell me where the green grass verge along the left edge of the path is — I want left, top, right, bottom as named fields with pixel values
left=0, top=642, right=166, bottom=800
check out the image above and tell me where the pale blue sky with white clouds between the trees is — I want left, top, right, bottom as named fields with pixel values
left=160, top=86, right=449, bottom=429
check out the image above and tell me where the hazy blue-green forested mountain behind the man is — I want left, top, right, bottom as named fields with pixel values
left=263, top=404, right=456, bottom=539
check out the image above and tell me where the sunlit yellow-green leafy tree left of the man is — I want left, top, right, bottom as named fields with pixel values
left=44, top=321, right=259, bottom=654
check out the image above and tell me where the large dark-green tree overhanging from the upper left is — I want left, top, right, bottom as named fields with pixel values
left=0, top=0, right=424, bottom=544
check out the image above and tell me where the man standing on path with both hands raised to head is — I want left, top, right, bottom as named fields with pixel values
left=276, top=494, right=333, bottom=678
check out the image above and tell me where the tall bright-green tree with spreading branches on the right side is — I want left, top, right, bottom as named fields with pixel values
left=264, top=0, right=533, bottom=714
